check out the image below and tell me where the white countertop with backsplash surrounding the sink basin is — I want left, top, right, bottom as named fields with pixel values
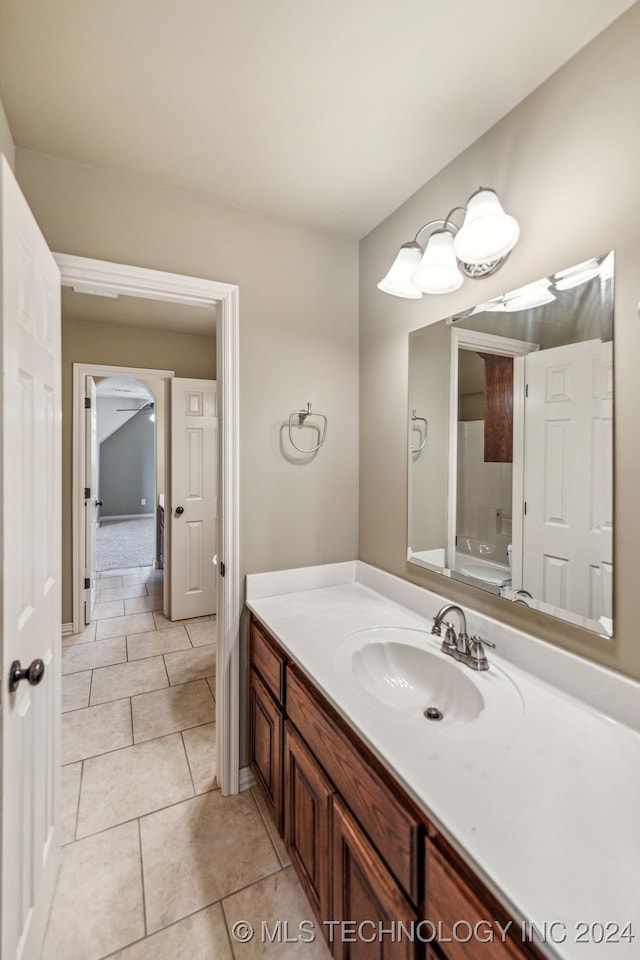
left=247, top=562, right=640, bottom=960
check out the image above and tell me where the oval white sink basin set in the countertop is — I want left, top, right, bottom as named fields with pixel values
left=335, top=627, right=522, bottom=732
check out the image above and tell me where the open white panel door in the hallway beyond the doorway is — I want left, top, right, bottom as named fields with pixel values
left=170, top=377, right=218, bottom=620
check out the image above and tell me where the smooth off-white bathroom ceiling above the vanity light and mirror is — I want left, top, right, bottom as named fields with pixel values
left=0, top=0, right=634, bottom=237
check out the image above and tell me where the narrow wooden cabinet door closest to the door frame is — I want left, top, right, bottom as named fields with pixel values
left=249, top=670, right=283, bottom=832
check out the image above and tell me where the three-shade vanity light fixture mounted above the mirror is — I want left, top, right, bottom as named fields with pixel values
left=378, top=187, right=520, bottom=300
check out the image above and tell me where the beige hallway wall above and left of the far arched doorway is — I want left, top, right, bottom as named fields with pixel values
left=62, top=316, right=216, bottom=623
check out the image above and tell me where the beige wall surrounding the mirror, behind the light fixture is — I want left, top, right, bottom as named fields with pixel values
left=360, top=5, right=640, bottom=677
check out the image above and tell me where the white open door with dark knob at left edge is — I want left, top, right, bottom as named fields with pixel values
left=0, top=157, right=62, bottom=960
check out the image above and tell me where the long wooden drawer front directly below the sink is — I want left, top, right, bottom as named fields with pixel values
left=287, top=667, right=421, bottom=903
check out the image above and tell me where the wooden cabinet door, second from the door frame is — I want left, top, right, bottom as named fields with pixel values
left=284, top=724, right=334, bottom=919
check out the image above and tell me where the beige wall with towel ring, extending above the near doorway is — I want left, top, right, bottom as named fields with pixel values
left=17, top=156, right=358, bottom=624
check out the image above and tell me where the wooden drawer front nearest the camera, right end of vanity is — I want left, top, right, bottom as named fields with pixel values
left=426, top=842, right=528, bottom=960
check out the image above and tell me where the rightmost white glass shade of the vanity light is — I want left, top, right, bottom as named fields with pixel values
left=454, top=190, right=520, bottom=263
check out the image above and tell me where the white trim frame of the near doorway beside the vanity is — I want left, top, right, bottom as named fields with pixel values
left=54, top=253, right=242, bottom=796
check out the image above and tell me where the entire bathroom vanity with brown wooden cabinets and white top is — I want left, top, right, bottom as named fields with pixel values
left=247, top=562, right=640, bottom=960
